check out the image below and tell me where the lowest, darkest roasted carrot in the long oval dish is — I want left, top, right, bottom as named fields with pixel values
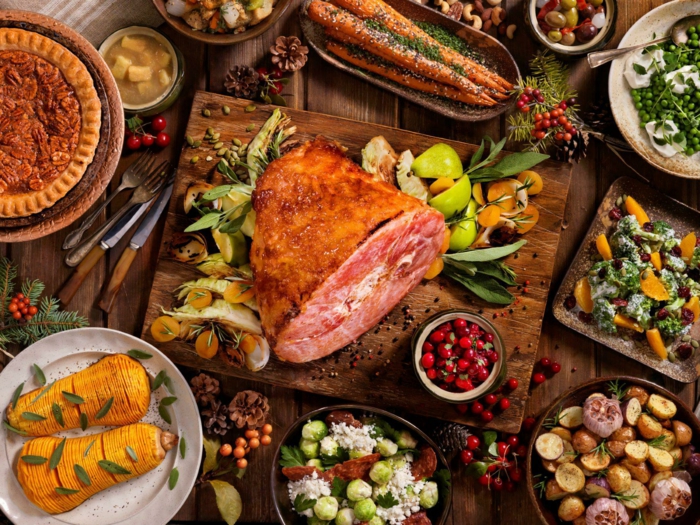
left=326, top=40, right=492, bottom=106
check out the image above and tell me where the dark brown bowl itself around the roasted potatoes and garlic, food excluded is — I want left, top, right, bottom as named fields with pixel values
left=525, top=376, right=700, bottom=525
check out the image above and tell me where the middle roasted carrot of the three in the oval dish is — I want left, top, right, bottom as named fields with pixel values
left=308, top=0, right=493, bottom=102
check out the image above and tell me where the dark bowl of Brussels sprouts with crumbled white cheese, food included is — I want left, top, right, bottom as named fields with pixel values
left=270, top=405, right=452, bottom=525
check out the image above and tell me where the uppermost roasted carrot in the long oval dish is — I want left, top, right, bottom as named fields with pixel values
left=334, top=0, right=513, bottom=92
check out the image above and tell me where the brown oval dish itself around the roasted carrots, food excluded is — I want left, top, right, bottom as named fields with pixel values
left=298, top=0, right=520, bottom=122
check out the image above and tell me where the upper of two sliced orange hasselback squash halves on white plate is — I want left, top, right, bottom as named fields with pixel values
left=7, top=354, right=151, bottom=436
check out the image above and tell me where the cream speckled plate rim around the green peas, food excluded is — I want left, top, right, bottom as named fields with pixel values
left=608, top=0, right=700, bottom=179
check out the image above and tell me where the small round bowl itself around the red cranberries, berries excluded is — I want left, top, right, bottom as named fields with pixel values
left=411, top=310, right=508, bottom=404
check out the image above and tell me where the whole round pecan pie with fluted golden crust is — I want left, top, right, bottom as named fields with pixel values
left=0, top=28, right=101, bottom=218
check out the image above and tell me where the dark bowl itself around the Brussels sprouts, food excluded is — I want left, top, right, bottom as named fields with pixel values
left=270, top=405, right=452, bottom=525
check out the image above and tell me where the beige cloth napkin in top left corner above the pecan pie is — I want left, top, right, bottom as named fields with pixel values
left=0, top=0, right=163, bottom=47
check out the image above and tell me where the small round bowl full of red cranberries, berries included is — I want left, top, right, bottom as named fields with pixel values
left=411, top=310, right=506, bottom=403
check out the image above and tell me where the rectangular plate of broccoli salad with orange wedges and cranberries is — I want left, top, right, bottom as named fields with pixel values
left=554, top=178, right=700, bottom=383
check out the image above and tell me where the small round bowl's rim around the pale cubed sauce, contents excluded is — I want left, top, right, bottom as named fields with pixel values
left=99, top=26, right=185, bottom=117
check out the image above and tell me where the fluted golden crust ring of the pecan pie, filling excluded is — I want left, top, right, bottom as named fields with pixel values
left=0, top=28, right=102, bottom=218
